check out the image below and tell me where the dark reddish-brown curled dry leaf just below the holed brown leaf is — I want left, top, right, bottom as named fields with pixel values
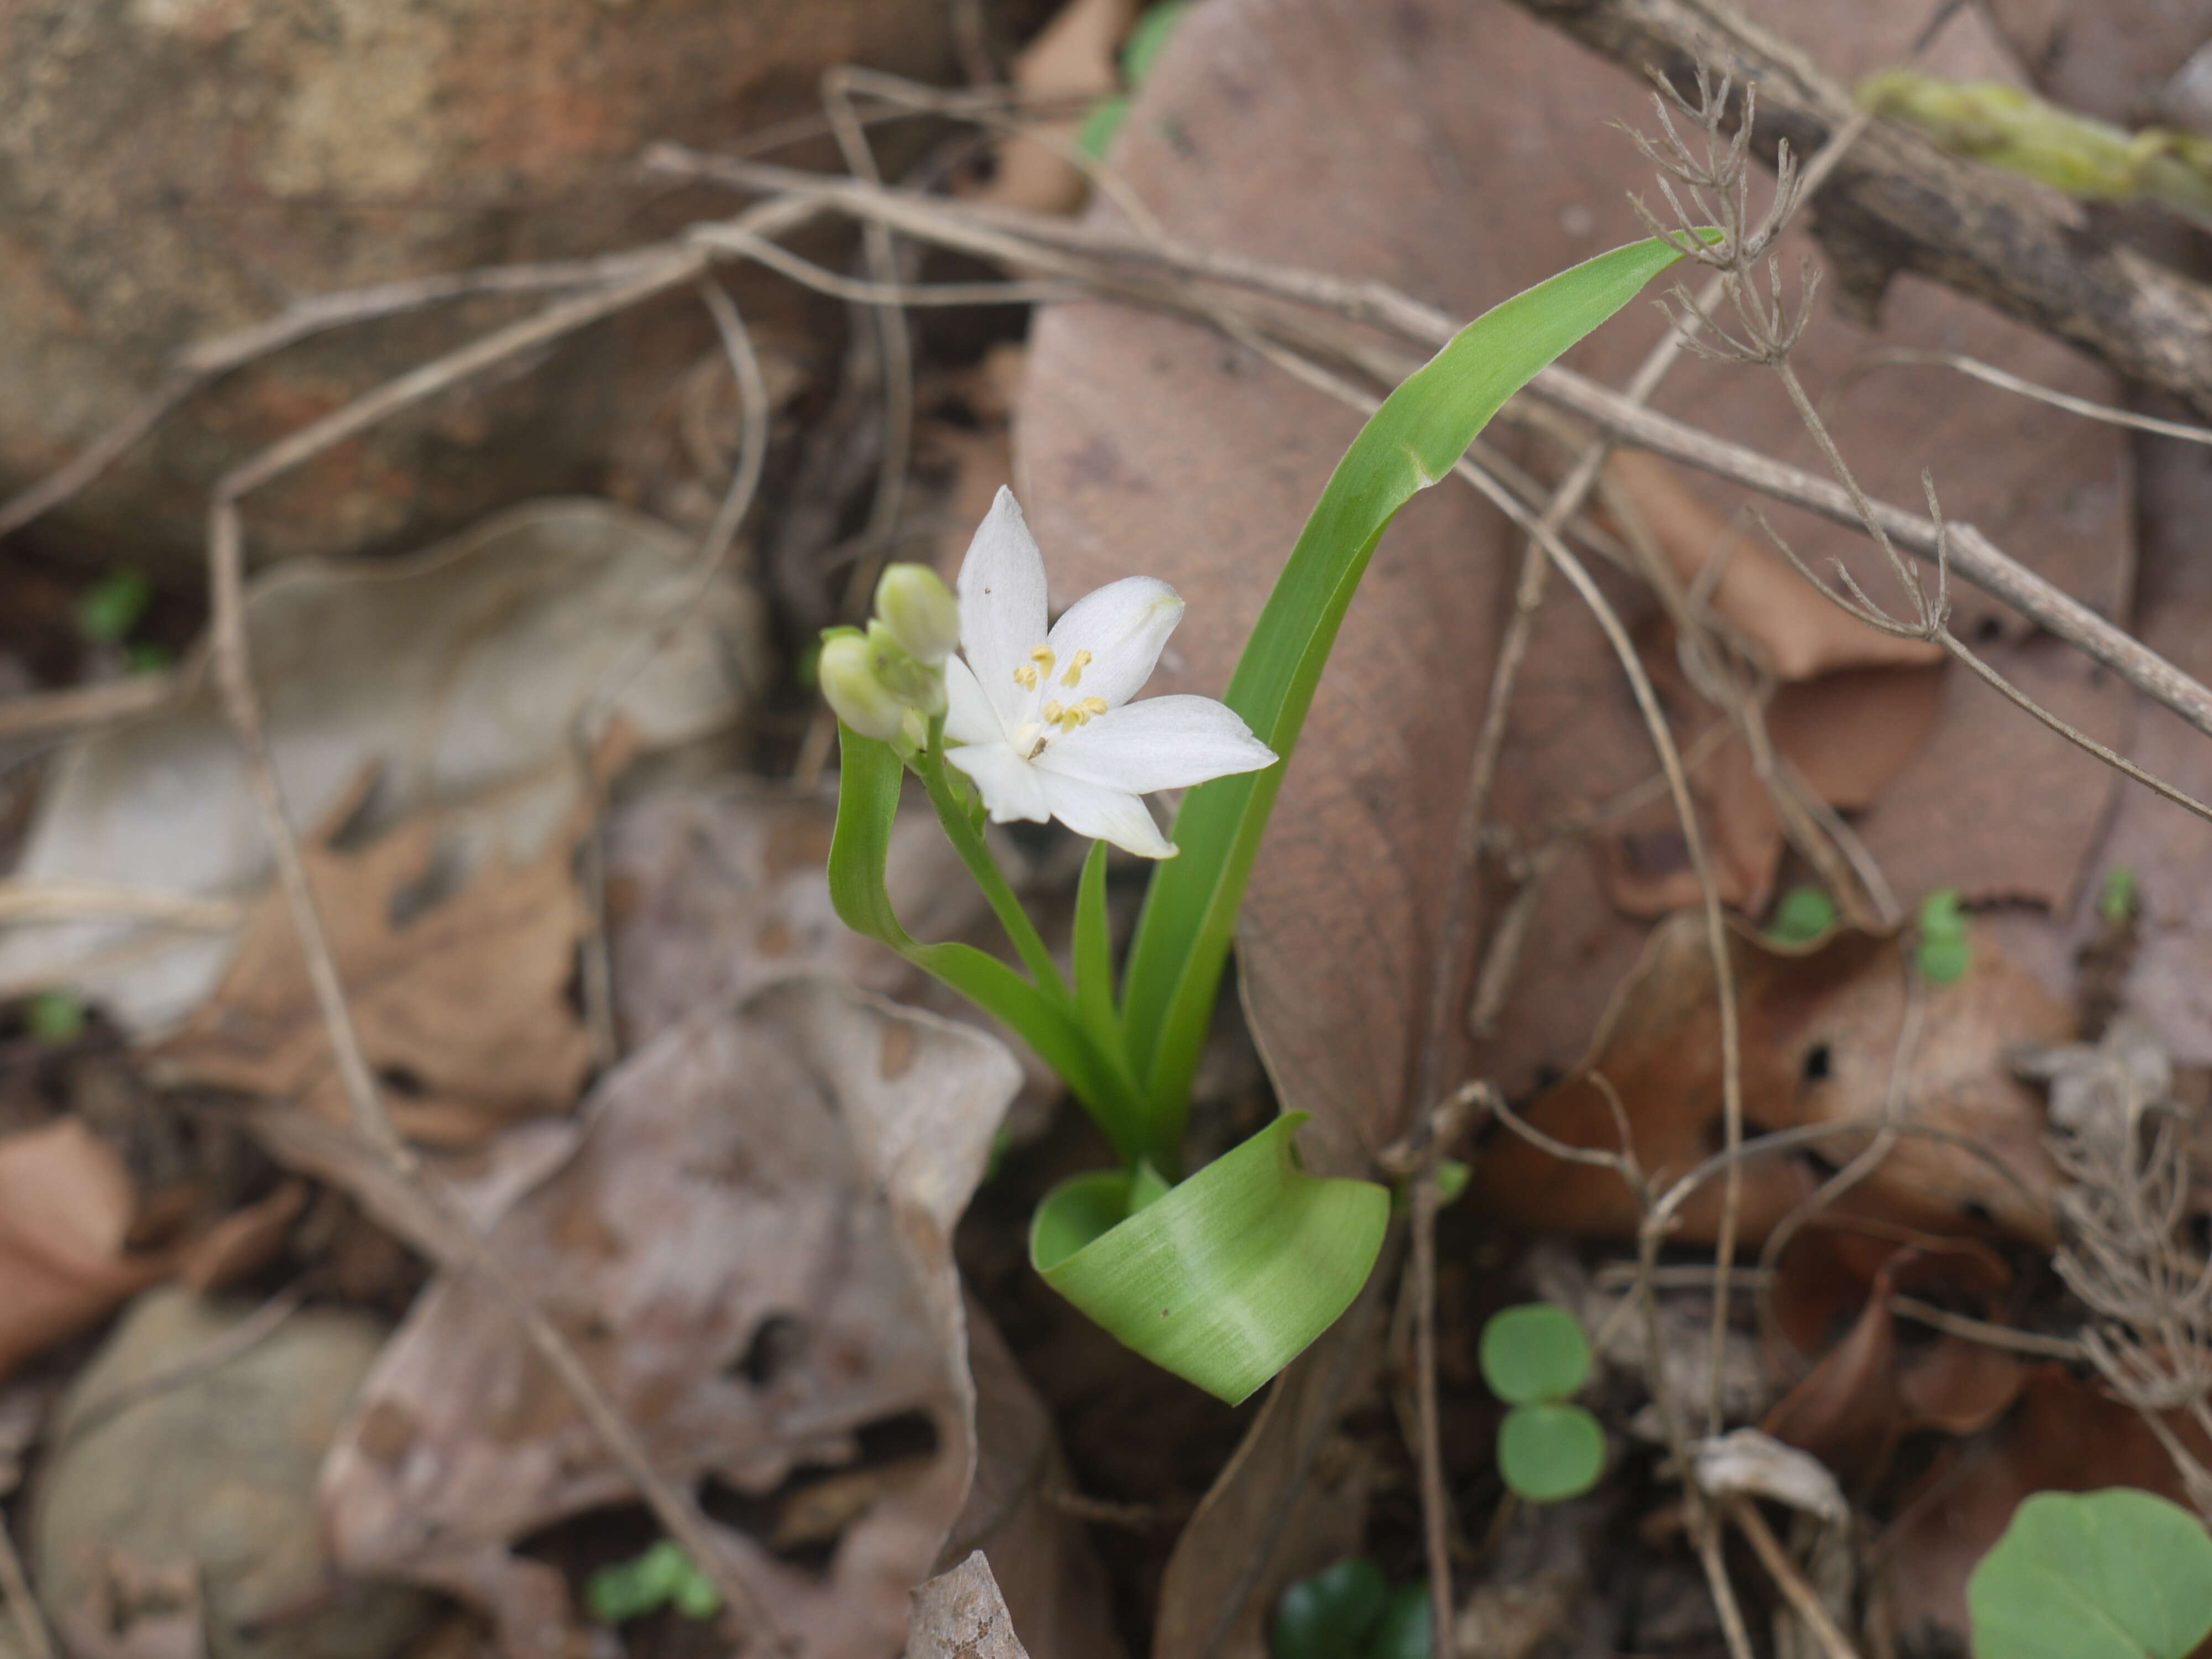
left=1761, top=1228, right=2026, bottom=1493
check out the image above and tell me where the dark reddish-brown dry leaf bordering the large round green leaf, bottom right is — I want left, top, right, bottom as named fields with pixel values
left=1876, top=1365, right=2212, bottom=1652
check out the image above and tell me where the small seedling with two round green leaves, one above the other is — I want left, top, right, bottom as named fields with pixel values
left=1482, top=1303, right=1606, bottom=1504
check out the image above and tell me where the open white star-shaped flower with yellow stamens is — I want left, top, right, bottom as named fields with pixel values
left=945, top=489, right=1274, bottom=858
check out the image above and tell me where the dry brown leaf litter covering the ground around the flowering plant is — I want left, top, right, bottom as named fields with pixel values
left=0, top=0, right=2212, bottom=1659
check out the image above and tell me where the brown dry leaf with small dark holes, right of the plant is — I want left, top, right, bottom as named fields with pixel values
left=1475, top=914, right=2070, bottom=1243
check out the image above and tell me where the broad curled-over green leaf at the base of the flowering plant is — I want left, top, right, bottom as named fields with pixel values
left=1029, top=1113, right=1389, bottom=1405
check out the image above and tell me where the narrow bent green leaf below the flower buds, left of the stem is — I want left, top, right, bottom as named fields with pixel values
left=830, top=728, right=1144, bottom=1161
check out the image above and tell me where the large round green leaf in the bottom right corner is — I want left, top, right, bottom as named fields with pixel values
left=1966, top=1486, right=2212, bottom=1659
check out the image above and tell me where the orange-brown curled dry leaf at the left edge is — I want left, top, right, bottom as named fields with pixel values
left=0, top=1117, right=305, bottom=1378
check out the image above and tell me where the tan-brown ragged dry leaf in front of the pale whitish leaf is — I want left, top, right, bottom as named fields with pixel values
left=153, top=783, right=591, bottom=1146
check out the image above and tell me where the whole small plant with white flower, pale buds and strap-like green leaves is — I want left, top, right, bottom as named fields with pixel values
left=821, top=239, right=1681, bottom=1402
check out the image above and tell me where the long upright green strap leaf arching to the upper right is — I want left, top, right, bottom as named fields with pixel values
left=1124, top=239, right=1681, bottom=1148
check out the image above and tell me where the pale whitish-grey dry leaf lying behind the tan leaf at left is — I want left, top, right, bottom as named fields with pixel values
left=0, top=500, right=770, bottom=1037
